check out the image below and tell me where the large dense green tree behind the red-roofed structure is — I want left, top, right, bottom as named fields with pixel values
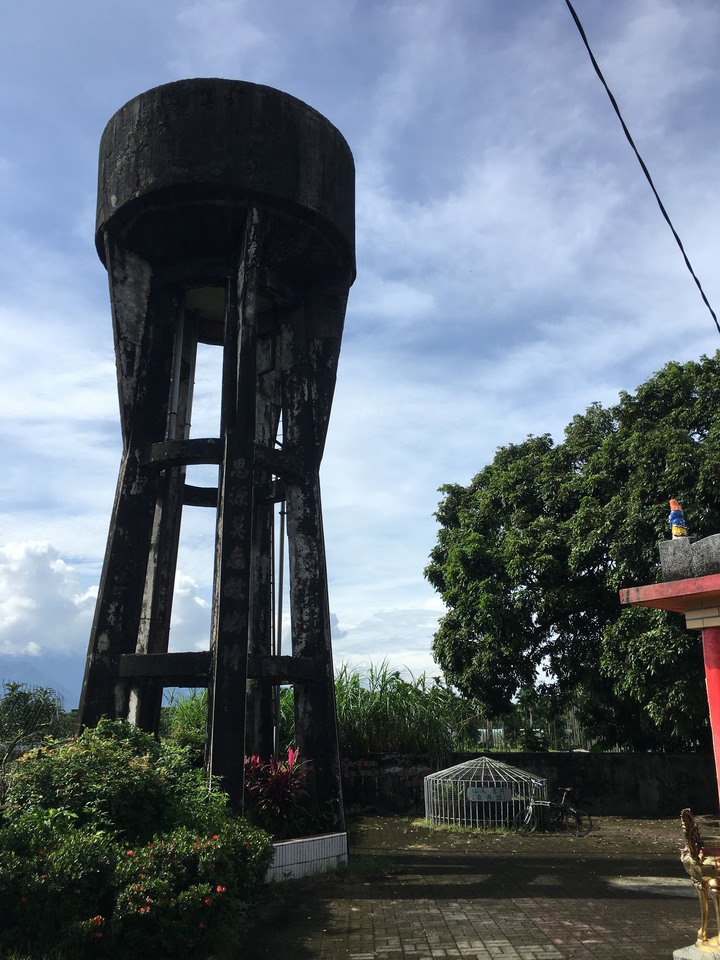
left=425, top=351, right=720, bottom=749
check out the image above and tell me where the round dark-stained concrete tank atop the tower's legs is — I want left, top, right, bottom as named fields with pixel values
left=96, top=78, right=355, bottom=275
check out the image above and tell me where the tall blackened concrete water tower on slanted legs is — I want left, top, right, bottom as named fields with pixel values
left=80, top=79, right=355, bottom=818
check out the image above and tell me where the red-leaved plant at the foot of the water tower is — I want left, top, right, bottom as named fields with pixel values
left=245, top=747, right=307, bottom=837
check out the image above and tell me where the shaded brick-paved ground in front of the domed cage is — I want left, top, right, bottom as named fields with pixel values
left=239, top=818, right=698, bottom=960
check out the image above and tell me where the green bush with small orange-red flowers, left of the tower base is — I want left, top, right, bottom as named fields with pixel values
left=0, top=721, right=271, bottom=960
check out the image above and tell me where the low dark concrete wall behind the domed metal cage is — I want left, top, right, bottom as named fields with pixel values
left=342, top=753, right=718, bottom=817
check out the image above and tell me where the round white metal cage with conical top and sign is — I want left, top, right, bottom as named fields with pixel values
left=425, top=757, right=547, bottom=829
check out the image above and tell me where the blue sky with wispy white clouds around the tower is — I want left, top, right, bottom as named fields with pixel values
left=0, top=0, right=720, bottom=705
